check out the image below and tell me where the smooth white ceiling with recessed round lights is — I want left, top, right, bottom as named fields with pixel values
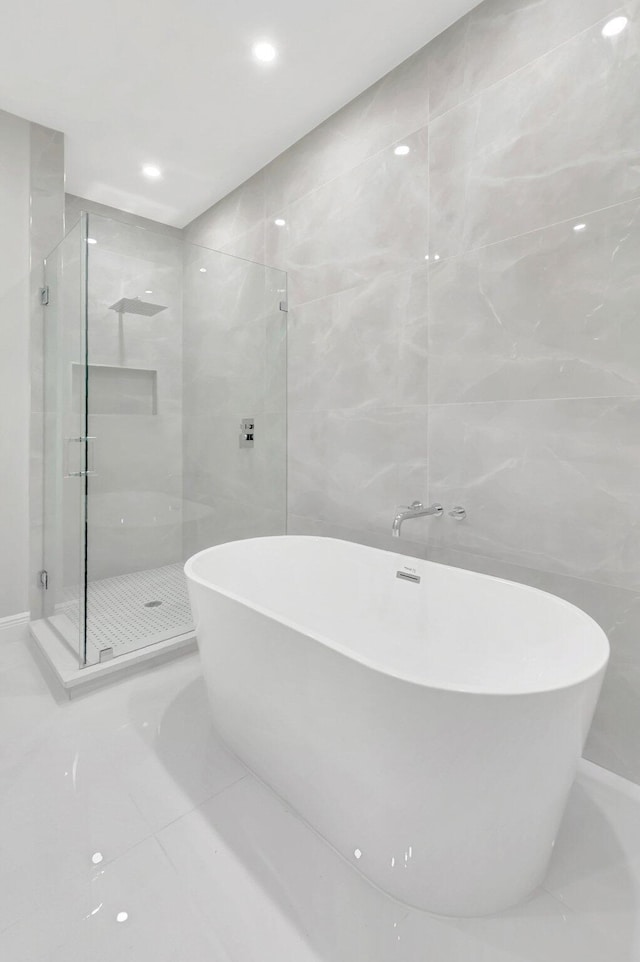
left=0, top=0, right=478, bottom=227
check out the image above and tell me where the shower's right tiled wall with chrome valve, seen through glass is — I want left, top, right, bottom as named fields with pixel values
left=183, top=245, right=287, bottom=557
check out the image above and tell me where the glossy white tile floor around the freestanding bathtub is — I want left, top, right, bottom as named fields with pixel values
left=0, top=616, right=640, bottom=962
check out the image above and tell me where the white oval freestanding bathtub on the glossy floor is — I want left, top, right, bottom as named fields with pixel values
left=185, top=537, right=609, bottom=916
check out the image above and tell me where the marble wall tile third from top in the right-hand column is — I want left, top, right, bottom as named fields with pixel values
left=429, top=202, right=640, bottom=402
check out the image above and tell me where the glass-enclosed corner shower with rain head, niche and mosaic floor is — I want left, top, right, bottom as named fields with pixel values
left=31, top=213, right=287, bottom=689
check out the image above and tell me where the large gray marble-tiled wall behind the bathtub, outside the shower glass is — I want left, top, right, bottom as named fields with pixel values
left=186, top=0, right=640, bottom=781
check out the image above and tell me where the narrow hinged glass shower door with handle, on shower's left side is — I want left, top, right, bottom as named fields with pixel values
left=42, top=216, right=91, bottom=665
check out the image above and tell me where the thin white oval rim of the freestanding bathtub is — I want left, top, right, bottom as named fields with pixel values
left=183, top=534, right=611, bottom=698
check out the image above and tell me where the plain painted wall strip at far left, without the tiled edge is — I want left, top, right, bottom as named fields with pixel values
left=0, top=111, right=31, bottom=618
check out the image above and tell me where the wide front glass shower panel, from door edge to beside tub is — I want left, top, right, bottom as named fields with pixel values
left=80, top=213, right=287, bottom=663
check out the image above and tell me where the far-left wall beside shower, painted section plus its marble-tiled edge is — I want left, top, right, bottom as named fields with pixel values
left=0, top=111, right=64, bottom=618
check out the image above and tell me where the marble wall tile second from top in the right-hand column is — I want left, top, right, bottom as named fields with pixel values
left=429, top=15, right=640, bottom=256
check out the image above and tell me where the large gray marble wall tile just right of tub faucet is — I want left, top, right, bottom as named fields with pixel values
left=429, top=398, right=640, bottom=590
